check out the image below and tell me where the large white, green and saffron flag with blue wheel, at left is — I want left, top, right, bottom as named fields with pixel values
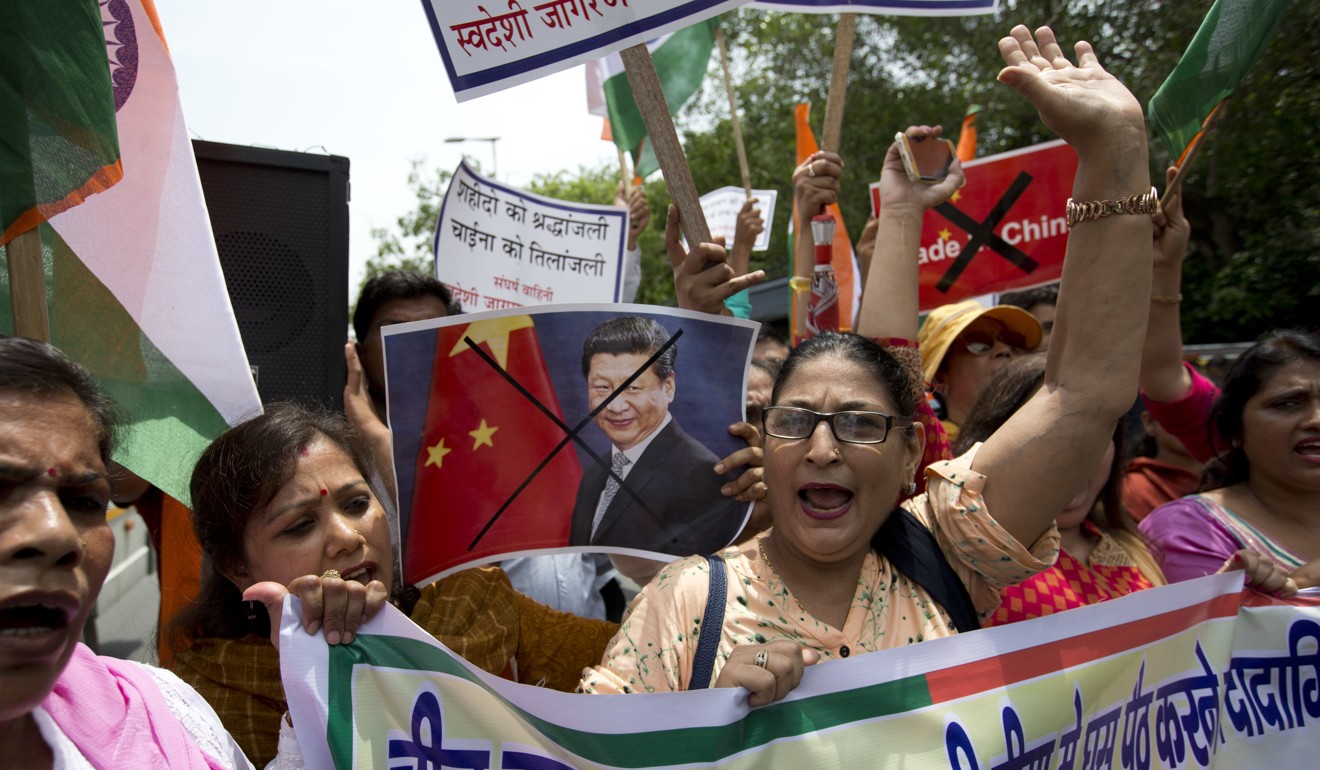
left=0, top=0, right=261, bottom=502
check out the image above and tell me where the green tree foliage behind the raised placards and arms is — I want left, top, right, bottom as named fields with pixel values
left=678, top=0, right=1320, bottom=342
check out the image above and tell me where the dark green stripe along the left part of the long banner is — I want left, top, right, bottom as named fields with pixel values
left=326, top=635, right=932, bottom=767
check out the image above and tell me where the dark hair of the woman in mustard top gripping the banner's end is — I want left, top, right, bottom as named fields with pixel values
left=166, top=403, right=374, bottom=650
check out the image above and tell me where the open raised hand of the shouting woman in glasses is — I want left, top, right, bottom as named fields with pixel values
left=999, top=24, right=1146, bottom=155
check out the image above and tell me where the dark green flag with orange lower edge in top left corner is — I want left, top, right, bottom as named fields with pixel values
left=0, top=0, right=123, bottom=247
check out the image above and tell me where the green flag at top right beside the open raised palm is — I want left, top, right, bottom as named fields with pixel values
left=1146, top=0, right=1292, bottom=164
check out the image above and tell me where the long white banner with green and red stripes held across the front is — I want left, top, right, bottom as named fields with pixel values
left=280, top=572, right=1320, bottom=770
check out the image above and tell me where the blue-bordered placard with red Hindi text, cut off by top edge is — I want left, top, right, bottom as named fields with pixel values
left=422, top=0, right=747, bottom=102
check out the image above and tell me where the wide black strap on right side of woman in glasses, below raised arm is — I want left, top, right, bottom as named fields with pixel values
left=871, top=508, right=981, bottom=634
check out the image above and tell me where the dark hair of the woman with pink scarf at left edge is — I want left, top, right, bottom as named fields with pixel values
left=0, top=334, right=123, bottom=465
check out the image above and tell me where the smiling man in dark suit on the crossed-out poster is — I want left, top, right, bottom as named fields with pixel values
left=569, top=316, right=747, bottom=556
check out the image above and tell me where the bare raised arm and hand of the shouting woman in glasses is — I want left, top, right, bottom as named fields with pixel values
left=973, top=25, right=1151, bottom=543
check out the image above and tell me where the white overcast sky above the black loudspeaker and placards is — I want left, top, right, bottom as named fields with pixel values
left=156, top=0, right=616, bottom=293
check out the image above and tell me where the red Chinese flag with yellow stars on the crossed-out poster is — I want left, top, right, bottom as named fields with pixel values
left=404, top=316, right=582, bottom=584
